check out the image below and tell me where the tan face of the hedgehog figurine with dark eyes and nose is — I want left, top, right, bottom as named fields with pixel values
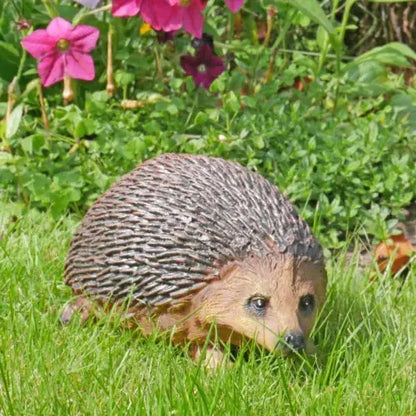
left=194, top=254, right=326, bottom=351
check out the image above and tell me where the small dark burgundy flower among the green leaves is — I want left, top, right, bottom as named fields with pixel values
left=181, top=43, right=225, bottom=88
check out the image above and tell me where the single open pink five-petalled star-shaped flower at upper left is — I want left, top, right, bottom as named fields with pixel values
left=22, top=17, right=100, bottom=87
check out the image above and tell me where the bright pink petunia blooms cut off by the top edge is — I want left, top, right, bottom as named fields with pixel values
left=111, top=0, right=244, bottom=38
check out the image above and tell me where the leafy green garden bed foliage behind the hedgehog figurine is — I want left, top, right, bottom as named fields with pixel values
left=0, top=0, right=416, bottom=246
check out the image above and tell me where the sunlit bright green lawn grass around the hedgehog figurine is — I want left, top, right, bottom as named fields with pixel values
left=0, top=204, right=416, bottom=416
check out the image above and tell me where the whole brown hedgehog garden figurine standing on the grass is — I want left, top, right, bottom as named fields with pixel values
left=62, top=154, right=326, bottom=366
